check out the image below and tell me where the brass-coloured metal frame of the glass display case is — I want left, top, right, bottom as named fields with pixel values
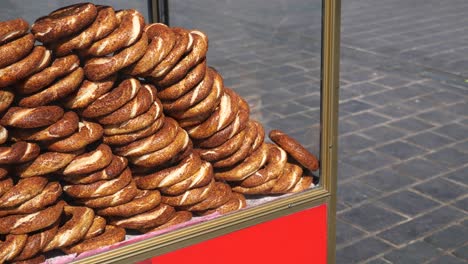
left=76, top=0, right=341, bottom=264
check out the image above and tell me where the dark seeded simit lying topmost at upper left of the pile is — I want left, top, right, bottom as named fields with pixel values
left=31, top=3, right=97, bottom=43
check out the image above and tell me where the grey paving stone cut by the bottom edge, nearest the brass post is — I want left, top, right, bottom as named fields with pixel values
left=336, top=237, right=392, bottom=263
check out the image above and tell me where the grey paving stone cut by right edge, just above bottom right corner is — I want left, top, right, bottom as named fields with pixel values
left=424, top=225, right=468, bottom=249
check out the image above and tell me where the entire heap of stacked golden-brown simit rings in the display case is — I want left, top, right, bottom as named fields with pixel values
left=0, top=3, right=318, bottom=263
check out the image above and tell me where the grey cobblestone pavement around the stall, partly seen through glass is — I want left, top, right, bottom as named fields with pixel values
left=0, top=0, right=468, bottom=264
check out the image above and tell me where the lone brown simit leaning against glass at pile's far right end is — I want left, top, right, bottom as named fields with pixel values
left=269, top=130, right=319, bottom=171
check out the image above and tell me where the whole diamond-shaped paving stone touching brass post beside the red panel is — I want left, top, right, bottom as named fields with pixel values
left=340, top=204, right=406, bottom=232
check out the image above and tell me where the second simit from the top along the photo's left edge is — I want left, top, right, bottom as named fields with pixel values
left=0, top=34, right=35, bottom=68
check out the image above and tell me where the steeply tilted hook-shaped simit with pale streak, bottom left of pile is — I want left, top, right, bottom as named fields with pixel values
left=43, top=205, right=94, bottom=252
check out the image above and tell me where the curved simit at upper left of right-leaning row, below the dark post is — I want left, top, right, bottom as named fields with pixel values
left=124, top=23, right=175, bottom=76
